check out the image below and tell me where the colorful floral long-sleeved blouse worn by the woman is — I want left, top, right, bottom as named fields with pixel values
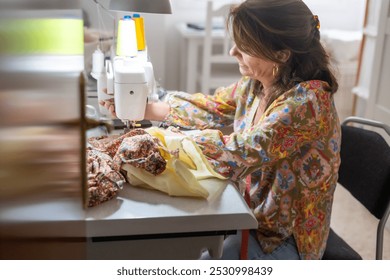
left=165, top=78, right=341, bottom=259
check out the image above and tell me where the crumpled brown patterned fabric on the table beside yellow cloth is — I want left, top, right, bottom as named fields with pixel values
left=87, top=129, right=166, bottom=207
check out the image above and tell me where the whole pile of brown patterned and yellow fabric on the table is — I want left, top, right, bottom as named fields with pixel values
left=87, top=127, right=225, bottom=207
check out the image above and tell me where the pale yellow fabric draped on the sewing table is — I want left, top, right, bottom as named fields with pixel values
left=122, top=127, right=225, bottom=198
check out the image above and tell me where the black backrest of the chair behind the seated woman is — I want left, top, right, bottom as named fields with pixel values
left=338, top=118, right=390, bottom=219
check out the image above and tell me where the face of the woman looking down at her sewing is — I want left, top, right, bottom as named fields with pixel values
left=230, top=45, right=275, bottom=87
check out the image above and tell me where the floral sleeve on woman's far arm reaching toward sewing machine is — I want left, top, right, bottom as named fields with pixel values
left=164, top=81, right=241, bottom=129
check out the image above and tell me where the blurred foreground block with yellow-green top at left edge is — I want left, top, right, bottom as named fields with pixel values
left=0, top=7, right=84, bottom=200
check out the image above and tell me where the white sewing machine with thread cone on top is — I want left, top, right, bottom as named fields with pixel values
left=91, top=12, right=158, bottom=128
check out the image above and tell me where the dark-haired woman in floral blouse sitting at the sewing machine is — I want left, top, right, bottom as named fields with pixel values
left=102, top=0, right=341, bottom=259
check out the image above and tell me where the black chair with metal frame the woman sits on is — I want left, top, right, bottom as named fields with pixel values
left=323, top=117, right=390, bottom=260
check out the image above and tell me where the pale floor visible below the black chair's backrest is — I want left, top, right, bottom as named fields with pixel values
left=331, top=186, right=390, bottom=260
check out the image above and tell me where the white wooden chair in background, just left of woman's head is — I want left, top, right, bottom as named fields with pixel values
left=201, top=0, right=239, bottom=93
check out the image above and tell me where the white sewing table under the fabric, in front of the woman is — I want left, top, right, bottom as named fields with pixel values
left=0, top=180, right=257, bottom=259
